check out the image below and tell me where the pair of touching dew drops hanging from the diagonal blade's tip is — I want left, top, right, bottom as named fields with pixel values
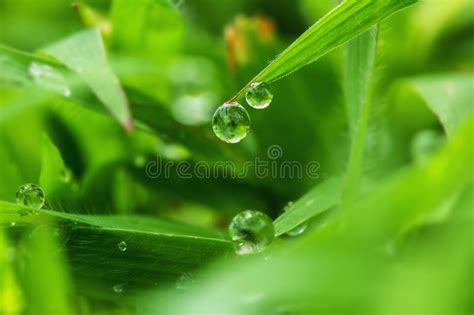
left=212, top=82, right=273, bottom=143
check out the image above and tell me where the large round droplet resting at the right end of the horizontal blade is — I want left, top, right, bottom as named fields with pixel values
left=229, top=210, right=275, bottom=255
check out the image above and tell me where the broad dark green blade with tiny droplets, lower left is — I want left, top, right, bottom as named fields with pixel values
left=0, top=201, right=233, bottom=303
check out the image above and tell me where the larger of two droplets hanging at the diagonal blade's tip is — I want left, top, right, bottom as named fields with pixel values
left=212, top=102, right=250, bottom=143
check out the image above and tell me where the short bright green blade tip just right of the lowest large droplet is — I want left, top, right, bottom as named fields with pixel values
left=274, top=177, right=342, bottom=236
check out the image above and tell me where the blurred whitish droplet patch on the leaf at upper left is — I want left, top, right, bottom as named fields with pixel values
left=29, top=62, right=71, bottom=97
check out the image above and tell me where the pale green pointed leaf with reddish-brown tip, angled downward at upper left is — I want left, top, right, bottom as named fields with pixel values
left=45, top=29, right=132, bottom=130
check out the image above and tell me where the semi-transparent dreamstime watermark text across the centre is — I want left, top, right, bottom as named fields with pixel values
left=145, top=145, right=320, bottom=179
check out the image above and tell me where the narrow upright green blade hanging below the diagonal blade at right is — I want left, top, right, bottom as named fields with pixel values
left=342, top=27, right=378, bottom=208
